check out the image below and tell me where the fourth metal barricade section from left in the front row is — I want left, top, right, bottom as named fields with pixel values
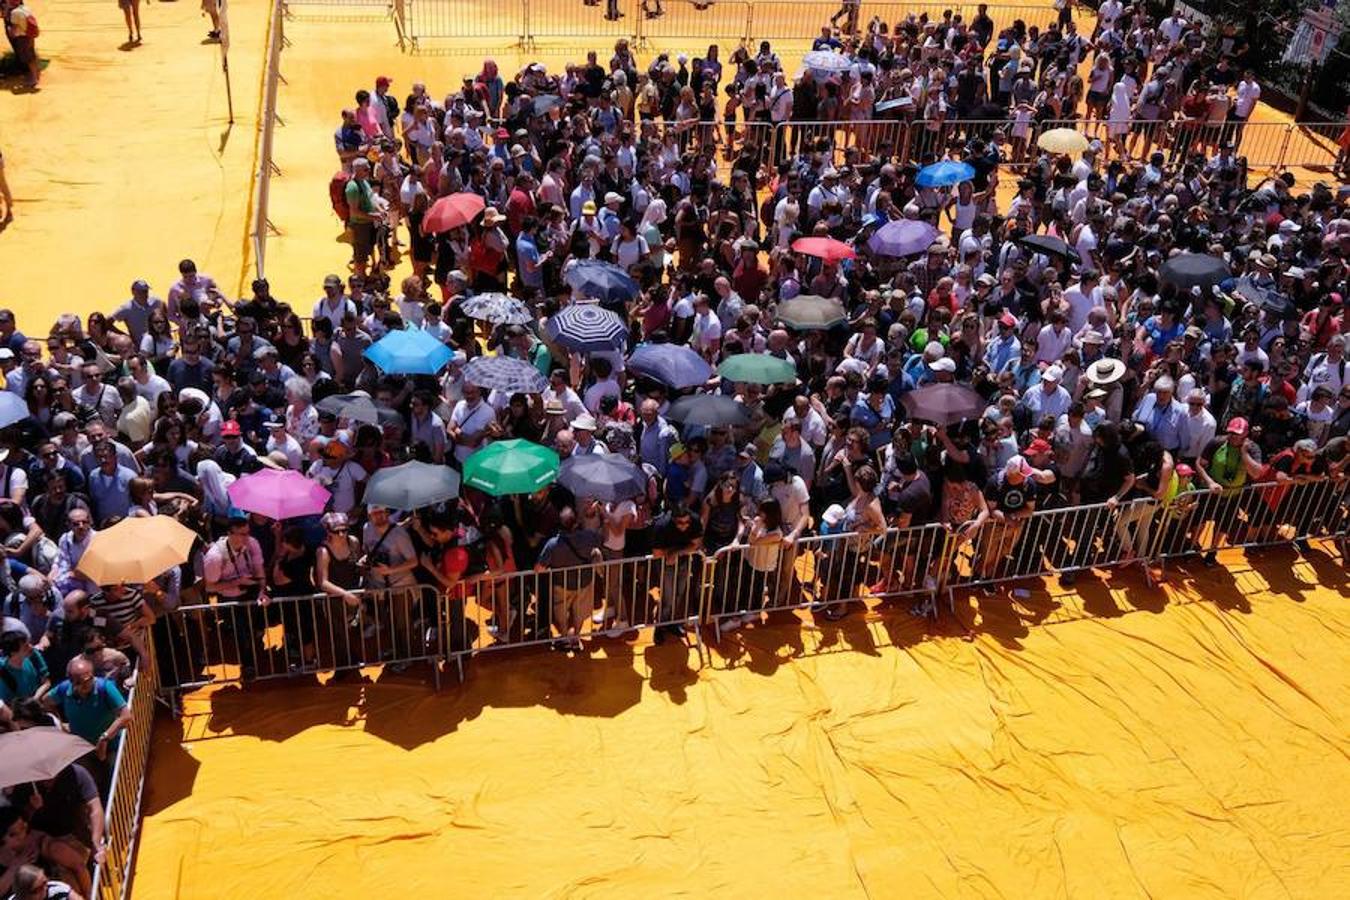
left=941, top=499, right=1160, bottom=599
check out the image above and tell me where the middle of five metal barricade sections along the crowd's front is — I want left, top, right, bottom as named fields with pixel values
left=703, top=525, right=948, bottom=630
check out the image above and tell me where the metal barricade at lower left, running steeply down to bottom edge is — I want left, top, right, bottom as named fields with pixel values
left=90, top=652, right=158, bottom=900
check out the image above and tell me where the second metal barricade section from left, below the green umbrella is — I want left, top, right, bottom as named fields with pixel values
left=443, top=553, right=705, bottom=671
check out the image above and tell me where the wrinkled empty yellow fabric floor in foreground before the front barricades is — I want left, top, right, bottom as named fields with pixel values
left=135, top=552, right=1350, bottom=897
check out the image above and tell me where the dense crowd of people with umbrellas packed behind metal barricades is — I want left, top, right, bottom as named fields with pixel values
left=0, top=0, right=1350, bottom=896
